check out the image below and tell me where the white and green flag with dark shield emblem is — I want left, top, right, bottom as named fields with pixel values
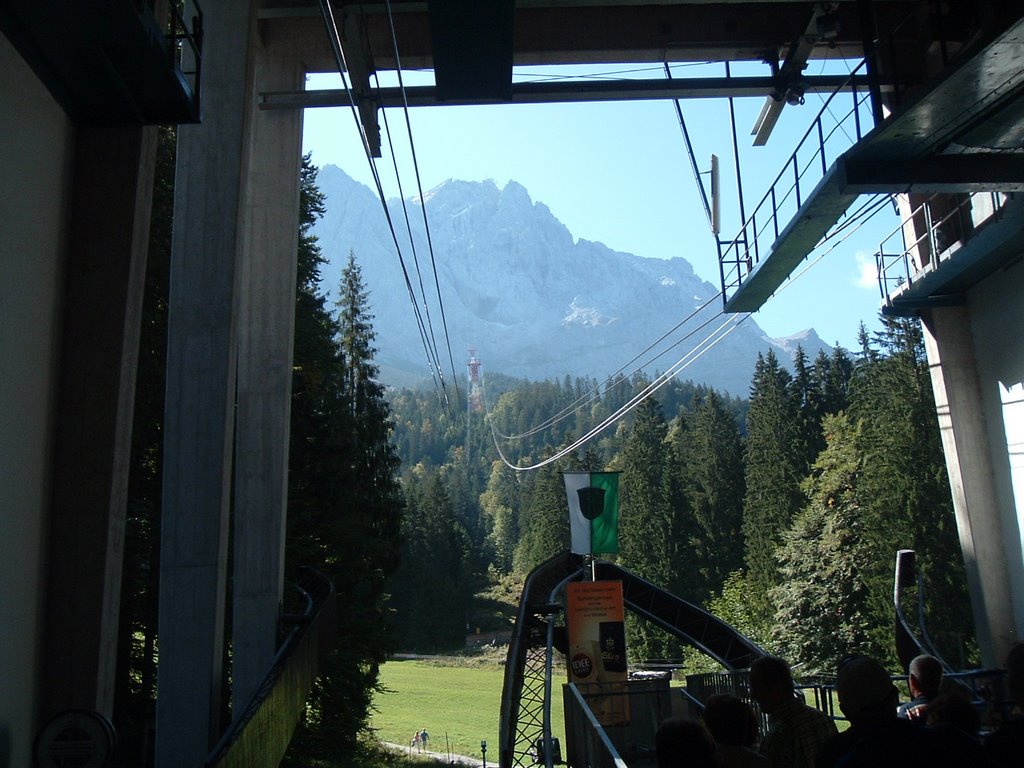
left=562, top=472, right=618, bottom=555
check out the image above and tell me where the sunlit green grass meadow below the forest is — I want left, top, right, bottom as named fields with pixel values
left=371, top=658, right=564, bottom=765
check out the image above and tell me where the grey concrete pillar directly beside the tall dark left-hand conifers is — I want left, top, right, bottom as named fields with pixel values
left=231, top=26, right=304, bottom=717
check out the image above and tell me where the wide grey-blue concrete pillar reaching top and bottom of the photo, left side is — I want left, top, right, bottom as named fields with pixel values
left=156, top=0, right=255, bottom=768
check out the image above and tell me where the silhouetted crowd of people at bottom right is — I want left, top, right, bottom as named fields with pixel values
left=655, top=643, right=1024, bottom=768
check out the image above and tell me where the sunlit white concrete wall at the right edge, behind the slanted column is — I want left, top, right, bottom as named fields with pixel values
left=968, top=260, right=1024, bottom=643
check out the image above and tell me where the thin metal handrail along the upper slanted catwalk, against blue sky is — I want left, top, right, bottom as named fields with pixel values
left=721, top=61, right=870, bottom=300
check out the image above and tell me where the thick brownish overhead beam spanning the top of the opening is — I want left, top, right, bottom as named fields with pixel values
left=259, top=0, right=915, bottom=72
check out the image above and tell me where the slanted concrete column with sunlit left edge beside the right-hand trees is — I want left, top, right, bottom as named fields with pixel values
left=923, top=306, right=1017, bottom=667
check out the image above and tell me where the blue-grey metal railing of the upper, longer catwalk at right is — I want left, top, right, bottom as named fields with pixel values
left=721, top=61, right=873, bottom=299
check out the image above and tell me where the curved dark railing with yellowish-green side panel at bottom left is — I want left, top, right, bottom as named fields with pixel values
left=205, top=568, right=337, bottom=768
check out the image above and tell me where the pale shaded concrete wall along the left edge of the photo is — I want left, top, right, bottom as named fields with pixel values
left=0, top=30, right=74, bottom=766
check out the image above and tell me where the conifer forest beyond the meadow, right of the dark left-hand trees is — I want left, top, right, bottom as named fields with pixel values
left=389, top=317, right=976, bottom=673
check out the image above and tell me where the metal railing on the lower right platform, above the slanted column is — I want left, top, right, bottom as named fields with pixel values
left=874, top=191, right=1008, bottom=304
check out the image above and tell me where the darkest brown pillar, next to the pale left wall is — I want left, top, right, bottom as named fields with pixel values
left=41, top=127, right=157, bottom=721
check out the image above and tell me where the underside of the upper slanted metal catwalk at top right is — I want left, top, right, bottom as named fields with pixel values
left=725, top=13, right=1024, bottom=312
